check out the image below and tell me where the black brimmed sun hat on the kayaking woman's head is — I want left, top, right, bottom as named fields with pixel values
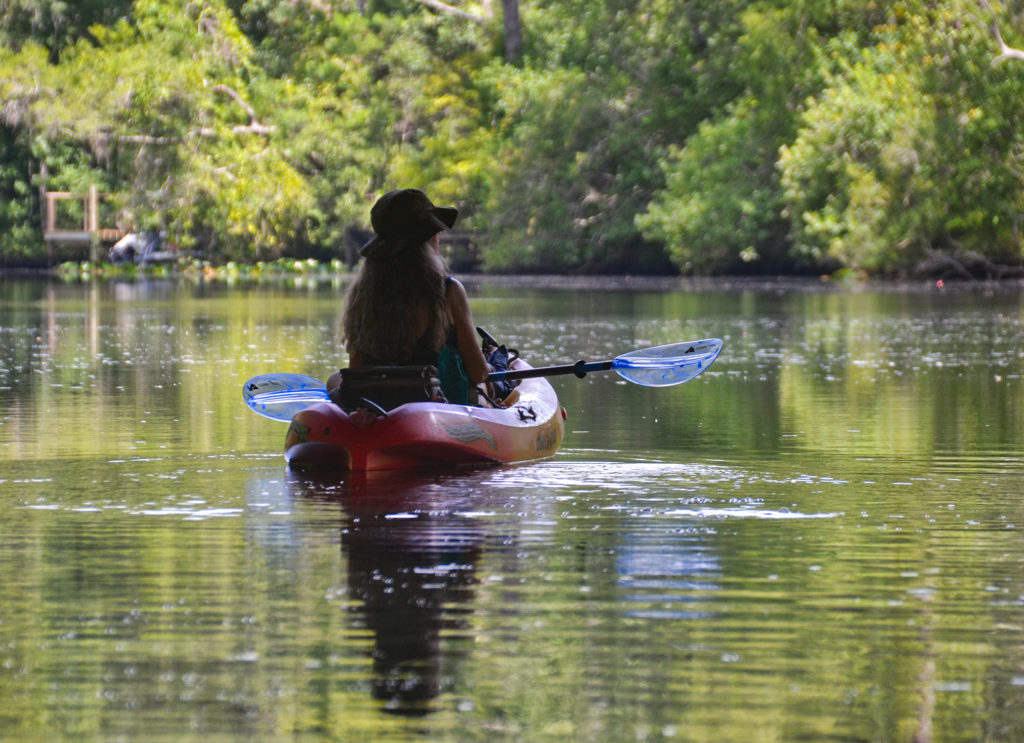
left=359, top=188, right=459, bottom=258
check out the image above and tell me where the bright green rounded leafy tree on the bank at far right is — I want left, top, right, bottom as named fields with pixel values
left=779, top=2, right=1024, bottom=271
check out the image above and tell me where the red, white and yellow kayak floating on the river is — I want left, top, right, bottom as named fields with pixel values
left=285, top=359, right=565, bottom=472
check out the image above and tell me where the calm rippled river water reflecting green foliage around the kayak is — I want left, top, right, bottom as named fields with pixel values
left=0, top=277, right=1024, bottom=743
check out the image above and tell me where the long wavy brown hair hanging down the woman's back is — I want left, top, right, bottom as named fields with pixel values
left=341, top=243, right=451, bottom=362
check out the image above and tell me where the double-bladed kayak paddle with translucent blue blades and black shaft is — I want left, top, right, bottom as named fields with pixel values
left=242, top=338, right=722, bottom=421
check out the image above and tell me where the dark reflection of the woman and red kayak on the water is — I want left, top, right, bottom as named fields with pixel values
left=288, top=474, right=484, bottom=715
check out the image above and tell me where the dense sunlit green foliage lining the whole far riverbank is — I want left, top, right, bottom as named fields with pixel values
left=0, top=0, right=1024, bottom=273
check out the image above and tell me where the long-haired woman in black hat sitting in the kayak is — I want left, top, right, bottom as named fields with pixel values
left=328, top=188, right=489, bottom=402
